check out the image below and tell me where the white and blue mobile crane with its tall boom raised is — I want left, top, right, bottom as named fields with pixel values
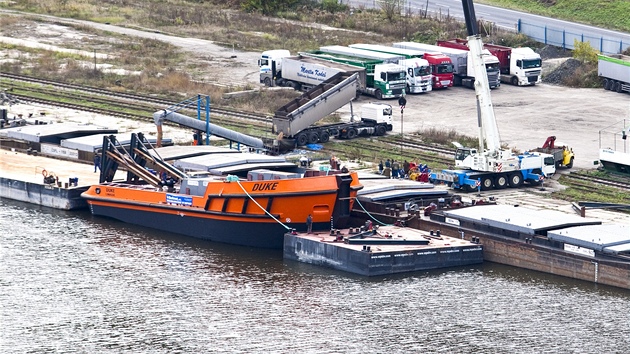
left=430, top=0, right=556, bottom=191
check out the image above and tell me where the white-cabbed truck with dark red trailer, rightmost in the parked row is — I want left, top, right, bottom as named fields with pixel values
left=437, top=38, right=542, bottom=86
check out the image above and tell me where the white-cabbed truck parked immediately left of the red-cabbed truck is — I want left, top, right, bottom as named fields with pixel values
left=349, top=43, right=434, bottom=93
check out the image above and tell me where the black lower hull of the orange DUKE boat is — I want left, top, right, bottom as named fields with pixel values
left=90, top=205, right=330, bottom=249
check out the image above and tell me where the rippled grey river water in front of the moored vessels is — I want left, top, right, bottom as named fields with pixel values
left=0, top=199, right=630, bottom=354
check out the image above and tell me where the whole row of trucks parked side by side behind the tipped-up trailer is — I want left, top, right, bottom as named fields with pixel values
left=258, top=38, right=544, bottom=99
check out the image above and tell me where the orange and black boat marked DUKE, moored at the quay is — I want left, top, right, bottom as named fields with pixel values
left=82, top=134, right=362, bottom=248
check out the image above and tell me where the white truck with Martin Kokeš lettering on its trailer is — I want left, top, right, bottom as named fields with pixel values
left=258, top=49, right=367, bottom=94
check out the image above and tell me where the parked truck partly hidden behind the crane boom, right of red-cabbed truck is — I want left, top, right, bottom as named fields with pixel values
left=394, top=42, right=501, bottom=88
